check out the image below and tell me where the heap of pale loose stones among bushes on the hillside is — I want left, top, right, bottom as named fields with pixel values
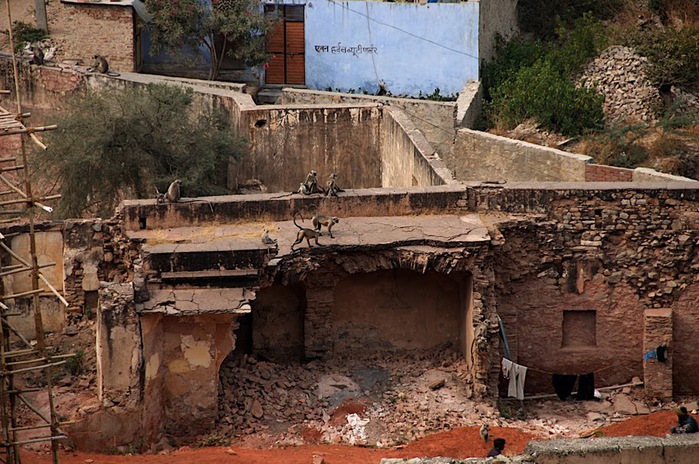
left=580, top=46, right=662, bottom=124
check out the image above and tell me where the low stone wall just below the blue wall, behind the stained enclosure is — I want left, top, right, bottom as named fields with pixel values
left=279, top=88, right=460, bottom=161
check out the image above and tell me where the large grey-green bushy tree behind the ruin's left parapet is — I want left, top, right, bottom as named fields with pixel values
left=31, top=84, right=245, bottom=217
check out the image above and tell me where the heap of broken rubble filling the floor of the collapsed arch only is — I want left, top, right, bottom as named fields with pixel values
left=219, top=349, right=482, bottom=446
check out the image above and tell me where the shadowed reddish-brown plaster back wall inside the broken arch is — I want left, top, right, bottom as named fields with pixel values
left=332, top=269, right=463, bottom=356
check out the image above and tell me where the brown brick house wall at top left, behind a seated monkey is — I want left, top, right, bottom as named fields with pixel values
left=47, top=1, right=136, bottom=71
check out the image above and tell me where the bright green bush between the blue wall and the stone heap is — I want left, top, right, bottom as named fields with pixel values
left=488, top=60, right=604, bottom=136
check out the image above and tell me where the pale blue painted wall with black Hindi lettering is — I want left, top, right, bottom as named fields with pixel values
left=304, top=0, right=479, bottom=96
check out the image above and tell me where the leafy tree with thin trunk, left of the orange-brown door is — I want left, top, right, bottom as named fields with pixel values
left=146, top=0, right=276, bottom=80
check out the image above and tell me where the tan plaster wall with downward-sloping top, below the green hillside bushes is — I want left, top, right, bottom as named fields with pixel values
left=452, top=129, right=592, bottom=182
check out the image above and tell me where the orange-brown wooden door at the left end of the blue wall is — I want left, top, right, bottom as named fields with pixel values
left=265, top=5, right=306, bottom=85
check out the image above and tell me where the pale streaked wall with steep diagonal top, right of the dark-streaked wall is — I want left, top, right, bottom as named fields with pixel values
left=381, top=107, right=454, bottom=187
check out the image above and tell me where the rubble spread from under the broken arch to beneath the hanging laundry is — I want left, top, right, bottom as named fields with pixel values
left=218, top=349, right=668, bottom=447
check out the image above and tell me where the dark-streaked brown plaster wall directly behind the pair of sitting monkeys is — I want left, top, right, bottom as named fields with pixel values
left=228, top=105, right=381, bottom=192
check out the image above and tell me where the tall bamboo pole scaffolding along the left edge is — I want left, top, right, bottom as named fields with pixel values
left=0, top=0, right=65, bottom=464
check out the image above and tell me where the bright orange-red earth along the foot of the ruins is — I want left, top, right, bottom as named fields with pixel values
left=22, top=411, right=677, bottom=464
